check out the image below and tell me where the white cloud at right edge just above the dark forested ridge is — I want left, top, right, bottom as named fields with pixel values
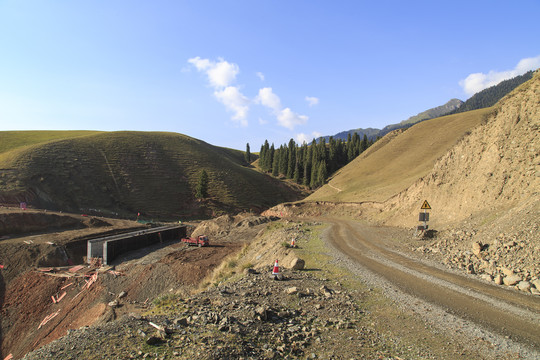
left=459, top=55, right=540, bottom=96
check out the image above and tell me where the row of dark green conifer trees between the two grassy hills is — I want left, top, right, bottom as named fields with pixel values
left=259, top=133, right=373, bottom=189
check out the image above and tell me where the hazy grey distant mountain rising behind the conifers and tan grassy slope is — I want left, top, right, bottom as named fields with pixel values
left=324, top=99, right=463, bottom=141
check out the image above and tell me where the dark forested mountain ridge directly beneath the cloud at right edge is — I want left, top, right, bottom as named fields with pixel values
left=452, top=70, right=533, bottom=114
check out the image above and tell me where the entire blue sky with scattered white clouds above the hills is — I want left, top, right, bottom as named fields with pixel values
left=0, top=0, right=540, bottom=151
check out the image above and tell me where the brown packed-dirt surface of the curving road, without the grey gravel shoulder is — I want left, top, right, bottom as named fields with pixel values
left=326, top=219, right=540, bottom=351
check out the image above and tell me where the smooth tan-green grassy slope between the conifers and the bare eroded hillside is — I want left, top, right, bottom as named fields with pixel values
left=307, top=108, right=493, bottom=202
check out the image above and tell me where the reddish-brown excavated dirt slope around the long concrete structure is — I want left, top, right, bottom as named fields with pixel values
left=0, top=210, right=268, bottom=359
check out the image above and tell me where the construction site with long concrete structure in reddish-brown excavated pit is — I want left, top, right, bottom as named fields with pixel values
left=0, top=207, right=249, bottom=359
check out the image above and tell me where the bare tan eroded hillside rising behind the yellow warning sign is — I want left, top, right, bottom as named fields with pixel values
left=379, top=72, right=540, bottom=225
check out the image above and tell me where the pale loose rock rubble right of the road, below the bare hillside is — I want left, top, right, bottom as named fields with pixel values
left=414, top=204, right=540, bottom=295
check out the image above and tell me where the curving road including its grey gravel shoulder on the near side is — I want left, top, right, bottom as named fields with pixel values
left=323, top=219, right=540, bottom=359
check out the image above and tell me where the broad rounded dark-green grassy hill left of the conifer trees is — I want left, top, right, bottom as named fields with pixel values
left=0, top=131, right=300, bottom=218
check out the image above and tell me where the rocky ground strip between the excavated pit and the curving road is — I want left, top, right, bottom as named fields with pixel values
left=19, top=219, right=530, bottom=360
